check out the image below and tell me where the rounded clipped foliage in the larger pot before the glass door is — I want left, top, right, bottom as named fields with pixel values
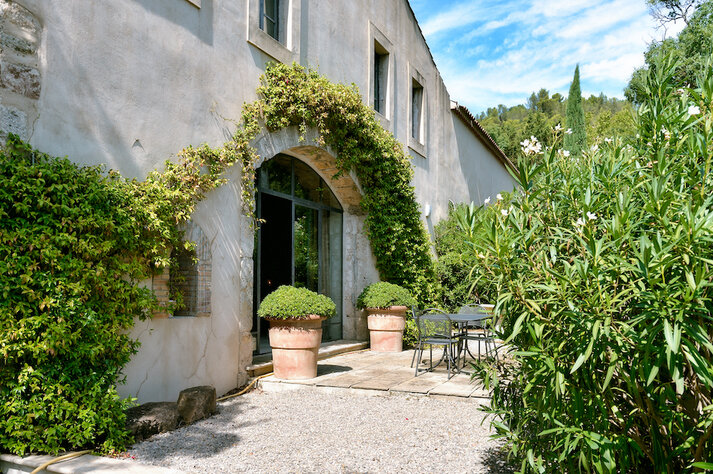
left=257, top=285, right=336, bottom=319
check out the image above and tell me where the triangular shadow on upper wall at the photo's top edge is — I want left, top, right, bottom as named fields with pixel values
left=135, top=0, right=215, bottom=46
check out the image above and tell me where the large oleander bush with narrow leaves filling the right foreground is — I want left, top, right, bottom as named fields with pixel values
left=474, top=54, right=713, bottom=473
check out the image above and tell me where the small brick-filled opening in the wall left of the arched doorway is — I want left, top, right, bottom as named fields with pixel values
left=152, top=223, right=212, bottom=318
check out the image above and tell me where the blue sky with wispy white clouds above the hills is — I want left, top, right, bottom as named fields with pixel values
left=410, top=0, right=680, bottom=113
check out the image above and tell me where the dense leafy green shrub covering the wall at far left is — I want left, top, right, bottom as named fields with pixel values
left=0, top=136, right=154, bottom=455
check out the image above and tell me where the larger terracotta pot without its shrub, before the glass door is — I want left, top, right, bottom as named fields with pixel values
left=266, top=314, right=326, bottom=380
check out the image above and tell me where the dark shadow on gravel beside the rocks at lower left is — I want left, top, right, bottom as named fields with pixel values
left=129, top=400, right=269, bottom=464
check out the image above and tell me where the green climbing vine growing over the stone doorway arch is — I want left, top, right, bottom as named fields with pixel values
left=176, top=64, right=436, bottom=302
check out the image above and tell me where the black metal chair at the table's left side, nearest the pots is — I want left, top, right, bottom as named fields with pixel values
left=411, top=308, right=461, bottom=379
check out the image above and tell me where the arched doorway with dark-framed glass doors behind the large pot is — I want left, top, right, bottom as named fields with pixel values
left=253, top=154, right=343, bottom=354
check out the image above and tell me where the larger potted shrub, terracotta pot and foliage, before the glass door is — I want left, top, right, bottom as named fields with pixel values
left=257, top=285, right=336, bottom=380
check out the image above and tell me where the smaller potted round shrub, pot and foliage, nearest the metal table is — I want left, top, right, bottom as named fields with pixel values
left=357, top=282, right=416, bottom=352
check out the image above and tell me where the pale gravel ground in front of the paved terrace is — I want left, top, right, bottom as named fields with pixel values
left=130, top=388, right=510, bottom=473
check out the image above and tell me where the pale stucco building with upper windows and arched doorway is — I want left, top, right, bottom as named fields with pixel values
left=0, top=0, right=513, bottom=402
